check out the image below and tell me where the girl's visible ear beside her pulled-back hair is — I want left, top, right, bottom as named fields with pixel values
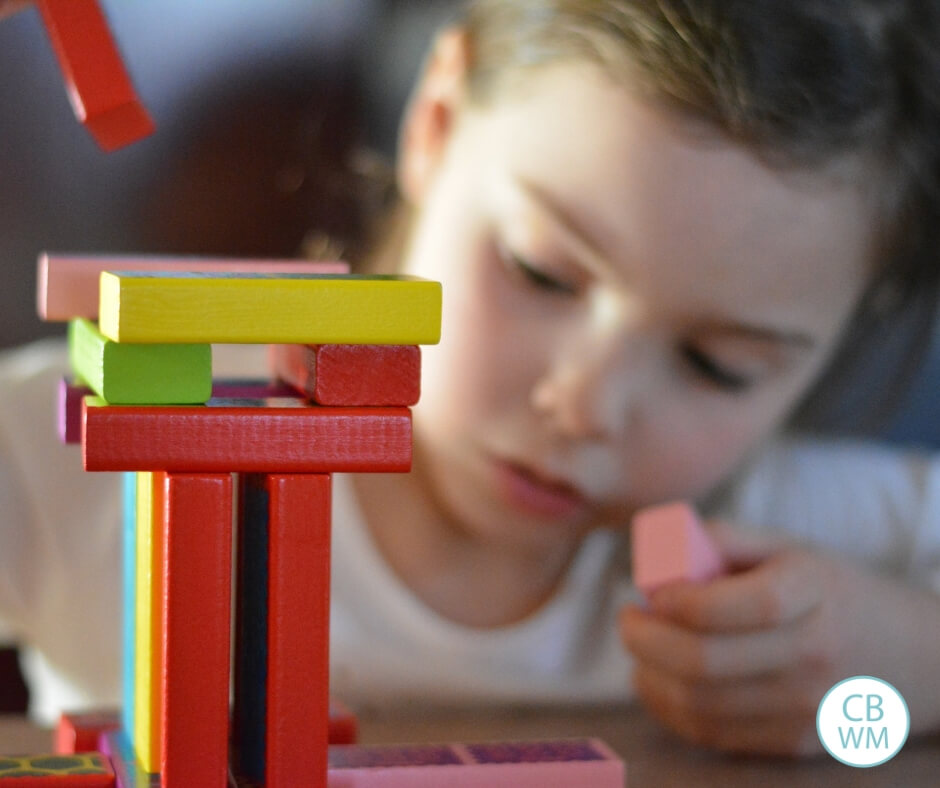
left=396, top=28, right=469, bottom=203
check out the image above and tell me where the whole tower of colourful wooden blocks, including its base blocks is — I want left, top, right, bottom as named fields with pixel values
left=7, top=256, right=623, bottom=788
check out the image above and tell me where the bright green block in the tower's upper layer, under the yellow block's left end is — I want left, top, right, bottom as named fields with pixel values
left=69, top=318, right=212, bottom=405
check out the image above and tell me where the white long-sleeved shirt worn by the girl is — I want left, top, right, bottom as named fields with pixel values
left=0, top=341, right=940, bottom=723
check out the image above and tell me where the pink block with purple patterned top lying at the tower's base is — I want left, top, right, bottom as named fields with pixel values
left=329, top=739, right=625, bottom=788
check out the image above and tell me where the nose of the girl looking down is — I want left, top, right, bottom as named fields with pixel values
left=531, top=296, right=650, bottom=440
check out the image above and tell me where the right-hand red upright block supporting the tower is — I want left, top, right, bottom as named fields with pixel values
left=265, top=474, right=331, bottom=788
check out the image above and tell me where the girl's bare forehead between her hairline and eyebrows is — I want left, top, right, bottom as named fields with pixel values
left=464, top=65, right=873, bottom=322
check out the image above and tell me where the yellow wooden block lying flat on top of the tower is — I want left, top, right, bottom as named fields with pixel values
left=98, top=272, right=441, bottom=345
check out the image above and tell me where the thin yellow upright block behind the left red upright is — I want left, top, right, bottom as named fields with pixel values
left=134, top=471, right=163, bottom=773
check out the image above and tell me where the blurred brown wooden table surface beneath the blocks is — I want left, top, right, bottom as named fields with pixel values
left=0, top=706, right=940, bottom=788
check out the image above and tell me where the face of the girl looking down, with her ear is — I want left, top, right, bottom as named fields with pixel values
left=401, top=53, right=870, bottom=546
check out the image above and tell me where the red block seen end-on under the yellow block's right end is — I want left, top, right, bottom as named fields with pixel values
left=268, top=345, right=421, bottom=406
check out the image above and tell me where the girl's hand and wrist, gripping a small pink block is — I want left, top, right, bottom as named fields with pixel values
left=620, top=526, right=940, bottom=756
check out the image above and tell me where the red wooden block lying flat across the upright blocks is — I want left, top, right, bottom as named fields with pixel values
left=82, top=397, right=411, bottom=473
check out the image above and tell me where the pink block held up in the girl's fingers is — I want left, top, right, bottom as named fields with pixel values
left=632, top=502, right=725, bottom=595
